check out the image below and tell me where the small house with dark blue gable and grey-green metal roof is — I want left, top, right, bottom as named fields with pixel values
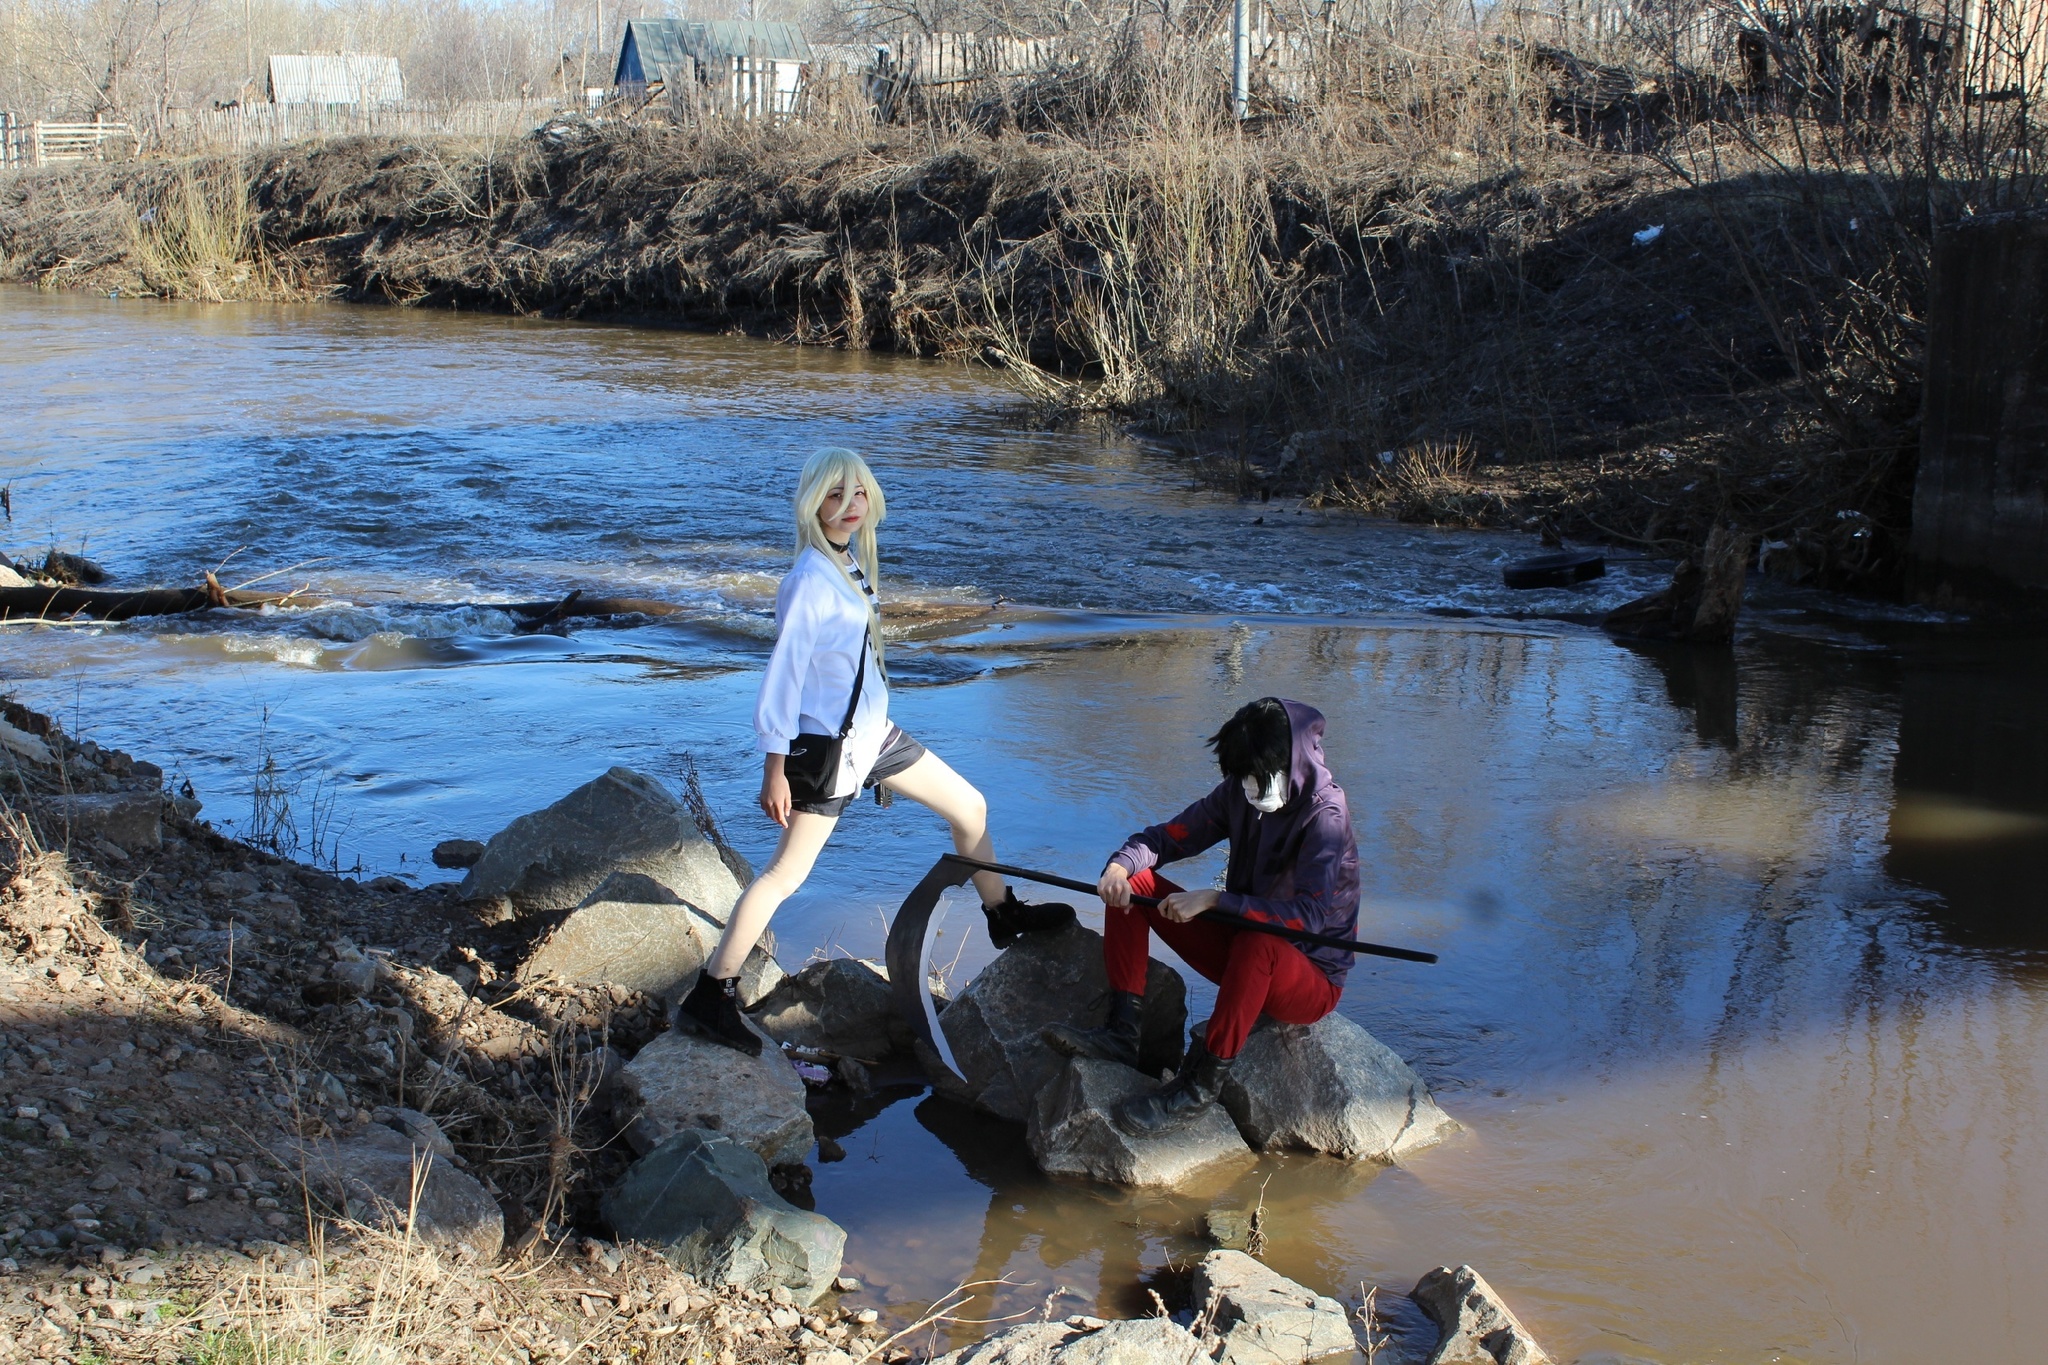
left=612, top=18, right=811, bottom=119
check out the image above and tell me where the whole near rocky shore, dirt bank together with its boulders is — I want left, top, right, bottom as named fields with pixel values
left=0, top=702, right=1544, bottom=1365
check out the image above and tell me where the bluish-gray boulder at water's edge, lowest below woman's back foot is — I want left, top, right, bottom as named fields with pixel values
left=602, top=1128, right=846, bottom=1304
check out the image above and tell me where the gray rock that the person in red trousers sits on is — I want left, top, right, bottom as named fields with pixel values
left=1223, top=1015, right=1458, bottom=1162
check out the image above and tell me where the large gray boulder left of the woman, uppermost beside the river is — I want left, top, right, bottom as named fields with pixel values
left=459, top=767, right=741, bottom=925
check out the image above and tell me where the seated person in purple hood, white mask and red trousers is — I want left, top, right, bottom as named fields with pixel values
left=1044, top=698, right=1358, bottom=1134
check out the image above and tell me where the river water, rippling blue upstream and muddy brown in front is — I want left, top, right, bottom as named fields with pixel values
left=0, top=291, right=2048, bottom=1363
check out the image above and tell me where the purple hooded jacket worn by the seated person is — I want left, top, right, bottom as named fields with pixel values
left=1110, top=700, right=1358, bottom=990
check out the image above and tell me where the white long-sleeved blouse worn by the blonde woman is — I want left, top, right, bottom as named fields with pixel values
left=754, top=546, right=889, bottom=796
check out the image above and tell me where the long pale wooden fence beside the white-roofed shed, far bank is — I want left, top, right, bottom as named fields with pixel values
left=156, top=100, right=559, bottom=151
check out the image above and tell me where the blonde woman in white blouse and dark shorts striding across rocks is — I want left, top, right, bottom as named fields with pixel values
left=674, top=448, right=1073, bottom=1054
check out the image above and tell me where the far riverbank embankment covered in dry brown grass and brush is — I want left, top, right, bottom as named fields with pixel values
left=0, top=123, right=1927, bottom=589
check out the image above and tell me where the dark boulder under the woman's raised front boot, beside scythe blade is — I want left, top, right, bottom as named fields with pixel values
left=926, top=925, right=1188, bottom=1124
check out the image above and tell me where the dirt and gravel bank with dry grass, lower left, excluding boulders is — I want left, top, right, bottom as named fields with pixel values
left=0, top=702, right=907, bottom=1365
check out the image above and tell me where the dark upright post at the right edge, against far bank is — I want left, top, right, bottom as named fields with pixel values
left=1913, top=213, right=2048, bottom=593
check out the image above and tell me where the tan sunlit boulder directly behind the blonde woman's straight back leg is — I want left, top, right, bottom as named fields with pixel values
left=518, top=872, right=782, bottom=1005
